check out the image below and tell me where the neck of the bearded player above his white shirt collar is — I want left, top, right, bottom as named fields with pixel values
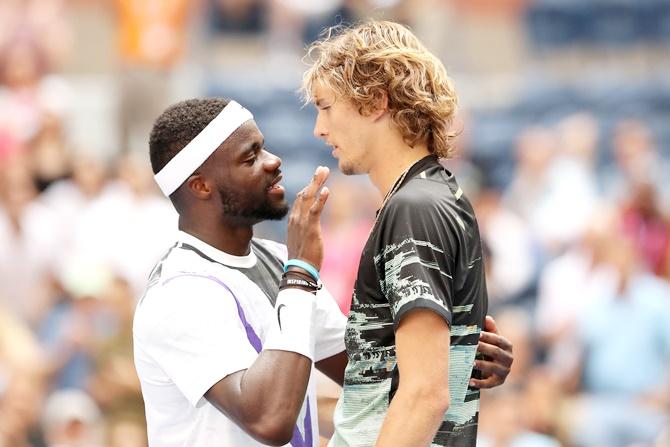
left=179, top=216, right=254, bottom=256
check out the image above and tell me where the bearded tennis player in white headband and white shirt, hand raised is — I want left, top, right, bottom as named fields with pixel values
left=133, top=99, right=346, bottom=447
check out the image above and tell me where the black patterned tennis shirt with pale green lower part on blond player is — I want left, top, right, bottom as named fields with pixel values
left=330, top=156, right=488, bottom=447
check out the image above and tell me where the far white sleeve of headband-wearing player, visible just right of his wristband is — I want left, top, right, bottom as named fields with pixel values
left=314, top=287, right=347, bottom=362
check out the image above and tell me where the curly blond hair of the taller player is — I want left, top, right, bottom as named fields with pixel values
left=301, top=20, right=458, bottom=158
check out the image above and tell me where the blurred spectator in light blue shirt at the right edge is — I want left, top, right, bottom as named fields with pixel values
left=560, top=237, right=670, bottom=447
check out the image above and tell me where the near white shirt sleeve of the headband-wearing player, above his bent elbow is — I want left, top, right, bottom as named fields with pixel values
left=140, top=276, right=258, bottom=406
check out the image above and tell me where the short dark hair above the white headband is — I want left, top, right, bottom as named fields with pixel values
left=149, top=98, right=230, bottom=174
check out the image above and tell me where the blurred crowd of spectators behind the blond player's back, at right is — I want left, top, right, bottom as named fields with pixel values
left=456, top=114, right=670, bottom=446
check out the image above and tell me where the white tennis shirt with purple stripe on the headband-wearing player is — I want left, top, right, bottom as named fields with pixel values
left=133, top=232, right=346, bottom=447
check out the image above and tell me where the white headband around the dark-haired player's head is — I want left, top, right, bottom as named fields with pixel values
left=154, top=101, right=254, bottom=197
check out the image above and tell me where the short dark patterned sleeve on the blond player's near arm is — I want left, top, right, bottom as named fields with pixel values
left=374, top=181, right=457, bottom=329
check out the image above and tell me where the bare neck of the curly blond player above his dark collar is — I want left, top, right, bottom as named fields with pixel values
left=370, top=142, right=430, bottom=197
